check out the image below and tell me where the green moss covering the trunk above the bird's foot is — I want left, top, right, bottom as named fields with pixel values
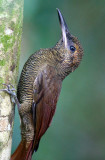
left=0, top=0, right=23, bottom=82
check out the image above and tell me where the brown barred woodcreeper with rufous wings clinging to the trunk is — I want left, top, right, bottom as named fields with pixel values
left=0, top=8, right=83, bottom=160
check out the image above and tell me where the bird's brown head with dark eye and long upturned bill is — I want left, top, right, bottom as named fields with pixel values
left=57, top=9, right=83, bottom=79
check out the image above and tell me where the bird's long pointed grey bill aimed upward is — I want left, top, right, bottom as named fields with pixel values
left=57, top=8, right=70, bottom=47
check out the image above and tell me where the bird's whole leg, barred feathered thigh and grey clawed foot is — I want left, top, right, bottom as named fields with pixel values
left=0, top=84, right=34, bottom=140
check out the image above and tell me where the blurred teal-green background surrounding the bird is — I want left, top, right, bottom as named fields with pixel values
left=12, top=0, right=105, bottom=160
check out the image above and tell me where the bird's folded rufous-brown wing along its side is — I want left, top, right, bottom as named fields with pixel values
left=32, top=66, right=61, bottom=151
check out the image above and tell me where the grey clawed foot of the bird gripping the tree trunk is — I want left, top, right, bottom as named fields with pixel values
left=0, top=83, right=20, bottom=110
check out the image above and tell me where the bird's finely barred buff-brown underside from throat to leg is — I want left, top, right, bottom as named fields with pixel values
left=17, top=49, right=56, bottom=103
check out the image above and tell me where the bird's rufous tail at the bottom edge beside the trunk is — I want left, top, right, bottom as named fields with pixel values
left=11, top=141, right=33, bottom=160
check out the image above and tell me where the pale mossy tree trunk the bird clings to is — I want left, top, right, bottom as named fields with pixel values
left=0, top=0, right=23, bottom=160
